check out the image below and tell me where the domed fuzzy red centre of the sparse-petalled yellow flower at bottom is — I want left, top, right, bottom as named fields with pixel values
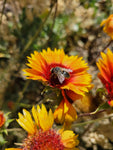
left=22, top=129, right=64, bottom=150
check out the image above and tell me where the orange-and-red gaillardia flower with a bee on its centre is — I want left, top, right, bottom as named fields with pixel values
left=24, top=48, right=91, bottom=96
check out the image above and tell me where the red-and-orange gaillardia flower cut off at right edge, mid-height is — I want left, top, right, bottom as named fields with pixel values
left=97, top=48, right=113, bottom=106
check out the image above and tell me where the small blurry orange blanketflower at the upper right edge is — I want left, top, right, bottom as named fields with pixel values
left=100, top=14, right=113, bottom=39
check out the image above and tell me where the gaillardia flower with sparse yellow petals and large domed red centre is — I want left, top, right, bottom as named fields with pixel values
left=5, top=105, right=79, bottom=150
